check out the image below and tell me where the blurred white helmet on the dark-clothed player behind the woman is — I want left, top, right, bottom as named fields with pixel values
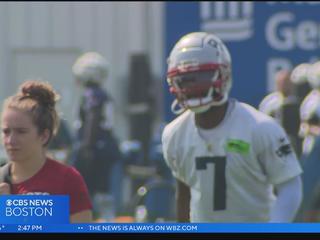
left=72, top=52, right=109, bottom=84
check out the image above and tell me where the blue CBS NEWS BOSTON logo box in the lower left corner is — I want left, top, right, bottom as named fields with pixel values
left=0, top=195, right=70, bottom=224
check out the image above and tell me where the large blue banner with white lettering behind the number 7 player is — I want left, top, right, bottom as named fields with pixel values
left=164, top=1, right=320, bottom=121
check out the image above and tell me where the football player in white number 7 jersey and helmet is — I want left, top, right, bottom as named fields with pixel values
left=162, top=32, right=302, bottom=222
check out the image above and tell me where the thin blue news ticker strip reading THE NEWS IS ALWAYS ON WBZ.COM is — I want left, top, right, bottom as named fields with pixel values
left=0, top=223, right=320, bottom=234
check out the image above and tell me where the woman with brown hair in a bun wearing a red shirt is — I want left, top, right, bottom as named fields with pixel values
left=0, top=80, right=92, bottom=223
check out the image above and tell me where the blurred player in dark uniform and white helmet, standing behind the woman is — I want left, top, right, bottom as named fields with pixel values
left=72, top=52, right=121, bottom=220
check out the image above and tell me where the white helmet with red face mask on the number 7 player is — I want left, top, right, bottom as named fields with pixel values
left=167, top=32, right=232, bottom=114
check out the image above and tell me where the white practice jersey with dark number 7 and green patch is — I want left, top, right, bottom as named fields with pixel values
left=162, top=99, right=302, bottom=222
